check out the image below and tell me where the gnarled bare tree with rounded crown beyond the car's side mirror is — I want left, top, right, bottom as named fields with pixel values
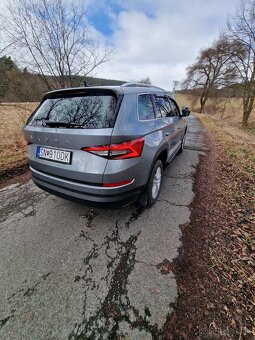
left=184, top=39, right=235, bottom=113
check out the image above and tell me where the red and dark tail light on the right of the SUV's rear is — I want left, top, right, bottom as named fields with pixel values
left=82, top=137, right=144, bottom=159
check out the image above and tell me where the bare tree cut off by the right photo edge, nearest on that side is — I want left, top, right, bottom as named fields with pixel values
left=224, top=0, right=255, bottom=127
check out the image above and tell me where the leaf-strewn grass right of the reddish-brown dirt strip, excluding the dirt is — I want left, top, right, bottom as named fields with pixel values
left=196, top=115, right=255, bottom=339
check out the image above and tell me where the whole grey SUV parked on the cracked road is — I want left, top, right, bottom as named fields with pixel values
left=24, top=83, right=189, bottom=206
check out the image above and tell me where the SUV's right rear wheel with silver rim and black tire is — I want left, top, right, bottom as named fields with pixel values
left=139, top=159, right=163, bottom=207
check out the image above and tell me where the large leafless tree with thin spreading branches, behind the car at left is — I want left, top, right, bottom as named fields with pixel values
left=1, top=0, right=110, bottom=89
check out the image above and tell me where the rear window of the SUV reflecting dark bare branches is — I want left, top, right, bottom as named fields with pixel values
left=27, top=94, right=117, bottom=129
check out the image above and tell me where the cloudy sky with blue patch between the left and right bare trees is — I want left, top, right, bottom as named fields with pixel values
left=88, top=0, right=239, bottom=89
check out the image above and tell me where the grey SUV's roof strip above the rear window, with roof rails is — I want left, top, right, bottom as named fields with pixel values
left=43, top=83, right=167, bottom=97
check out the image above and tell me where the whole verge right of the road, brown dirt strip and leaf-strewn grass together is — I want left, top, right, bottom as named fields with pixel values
left=164, top=115, right=255, bottom=340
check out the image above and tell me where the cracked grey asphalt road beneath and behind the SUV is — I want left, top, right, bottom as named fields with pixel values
left=0, top=116, right=206, bottom=339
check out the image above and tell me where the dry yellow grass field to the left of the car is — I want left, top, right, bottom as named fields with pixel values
left=0, top=103, right=37, bottom=170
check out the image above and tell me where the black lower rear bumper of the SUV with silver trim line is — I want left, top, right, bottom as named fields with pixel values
left=30, top=167, right=145, bottom=207
